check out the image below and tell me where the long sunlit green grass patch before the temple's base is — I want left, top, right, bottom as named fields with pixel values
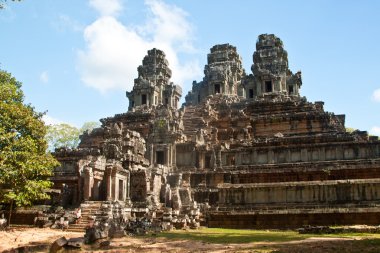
left=157, top=228, right=314, bottom=244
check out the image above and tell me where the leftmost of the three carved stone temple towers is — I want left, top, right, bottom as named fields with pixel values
left=127, top=48, right=182, bottom=111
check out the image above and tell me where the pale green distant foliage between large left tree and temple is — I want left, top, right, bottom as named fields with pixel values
left=46, top=122, right=100, bottom=149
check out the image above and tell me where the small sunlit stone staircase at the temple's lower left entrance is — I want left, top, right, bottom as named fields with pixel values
left=67, top=201, right=102, bottom=232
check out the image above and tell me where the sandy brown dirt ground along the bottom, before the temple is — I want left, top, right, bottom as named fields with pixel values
left=0, top=228, right=380, bottom=253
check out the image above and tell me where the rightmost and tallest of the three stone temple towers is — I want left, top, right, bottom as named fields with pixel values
left=243, top=34, right=302, bottom=98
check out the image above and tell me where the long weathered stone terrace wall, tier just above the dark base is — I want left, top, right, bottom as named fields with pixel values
left=218, top=179, right=380, bottom=205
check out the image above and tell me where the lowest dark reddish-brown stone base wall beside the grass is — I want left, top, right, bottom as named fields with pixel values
left=207, top=210, right=380, bottom=229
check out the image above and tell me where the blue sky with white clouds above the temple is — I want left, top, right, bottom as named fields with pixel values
left=0, top=0, right=380, bottom=135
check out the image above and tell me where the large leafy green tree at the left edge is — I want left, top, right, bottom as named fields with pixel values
left=0, top=70, right=59, bottom=223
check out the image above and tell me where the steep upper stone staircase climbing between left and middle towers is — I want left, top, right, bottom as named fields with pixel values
left=183, top=106, right=206, bottom=138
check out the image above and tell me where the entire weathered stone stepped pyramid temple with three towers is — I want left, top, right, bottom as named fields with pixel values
left=52, top=34, right=380, bottom=228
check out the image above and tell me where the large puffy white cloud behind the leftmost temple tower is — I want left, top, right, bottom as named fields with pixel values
left=78, top=0, right=202, bottom=92
